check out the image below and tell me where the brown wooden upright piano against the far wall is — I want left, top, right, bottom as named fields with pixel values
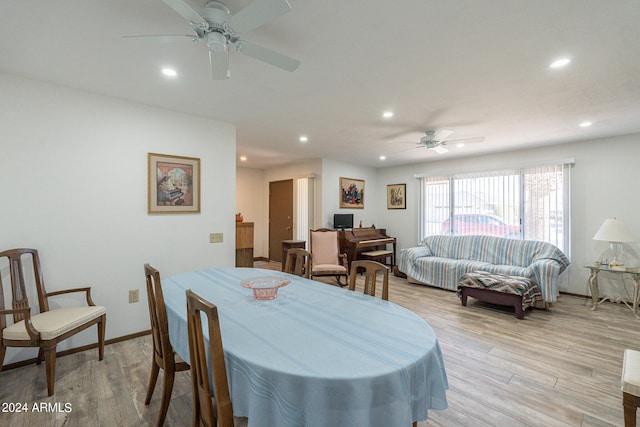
left=338, top=227, right=396, bottom=268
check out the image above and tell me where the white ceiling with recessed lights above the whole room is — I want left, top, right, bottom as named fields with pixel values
left=0, top=0, right=640, bottom=168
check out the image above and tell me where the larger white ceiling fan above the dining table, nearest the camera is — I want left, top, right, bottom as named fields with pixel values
left=124, top=0, right=300, bottom=80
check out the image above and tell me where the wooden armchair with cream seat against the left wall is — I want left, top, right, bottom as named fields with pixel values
left=0, top=248, right=107, bottom=396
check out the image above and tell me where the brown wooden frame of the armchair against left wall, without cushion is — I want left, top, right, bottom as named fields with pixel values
left=0, top=248, right=107, bottom=396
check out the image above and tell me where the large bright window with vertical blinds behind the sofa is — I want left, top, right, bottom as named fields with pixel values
left=421, top=163, right=570, bottom=254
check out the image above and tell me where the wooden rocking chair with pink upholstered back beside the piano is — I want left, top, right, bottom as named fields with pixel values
left=309, top=228, right=349, bottom=286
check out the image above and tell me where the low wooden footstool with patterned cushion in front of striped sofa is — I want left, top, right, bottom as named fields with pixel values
left=458, top=271, right=541, bottom=319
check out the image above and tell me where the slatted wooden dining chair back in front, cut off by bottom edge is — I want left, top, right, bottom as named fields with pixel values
left=187, top=289, right=234, bottom=427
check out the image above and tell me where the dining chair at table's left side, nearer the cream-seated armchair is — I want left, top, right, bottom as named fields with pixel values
left=144, top=264, right=189, bottom=427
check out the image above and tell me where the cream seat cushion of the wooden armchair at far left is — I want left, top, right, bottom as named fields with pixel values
left=2, top=305, right=106, bottom=341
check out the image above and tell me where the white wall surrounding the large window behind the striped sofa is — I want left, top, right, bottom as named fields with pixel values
left=377, top=134, right=640, bottom=295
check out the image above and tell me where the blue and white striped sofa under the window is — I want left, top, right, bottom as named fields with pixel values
left=398, top=236, right=569, bottom=302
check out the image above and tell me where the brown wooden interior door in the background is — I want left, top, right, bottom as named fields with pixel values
left=269, top=179, right=293, bottom=262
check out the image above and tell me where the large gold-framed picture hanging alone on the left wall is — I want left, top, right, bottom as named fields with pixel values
left=148, top=153, right=200, bottom=214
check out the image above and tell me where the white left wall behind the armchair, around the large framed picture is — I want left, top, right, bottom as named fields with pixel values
left=0, top=74, right=236, bottom=363
